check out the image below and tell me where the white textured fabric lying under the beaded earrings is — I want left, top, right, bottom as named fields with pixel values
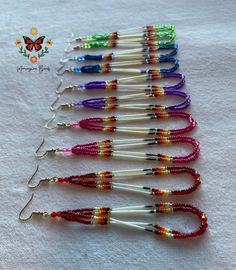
left=0, top=0, right=236, bottom=270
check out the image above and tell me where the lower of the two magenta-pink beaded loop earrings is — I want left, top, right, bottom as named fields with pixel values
left=35, top=136, right=200, bottom=163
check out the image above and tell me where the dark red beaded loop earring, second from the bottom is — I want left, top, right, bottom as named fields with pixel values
left=28, top=165, right=201, bottom=196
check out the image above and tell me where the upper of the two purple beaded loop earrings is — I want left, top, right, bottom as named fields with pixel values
left=56, top=70, right=185, bottom=95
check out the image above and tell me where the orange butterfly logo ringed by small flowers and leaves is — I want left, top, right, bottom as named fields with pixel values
left=15, top=27, right=52, bottom=64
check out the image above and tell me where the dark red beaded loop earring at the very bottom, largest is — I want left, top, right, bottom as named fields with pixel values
left=19, top=194, right=208, bottom=239
